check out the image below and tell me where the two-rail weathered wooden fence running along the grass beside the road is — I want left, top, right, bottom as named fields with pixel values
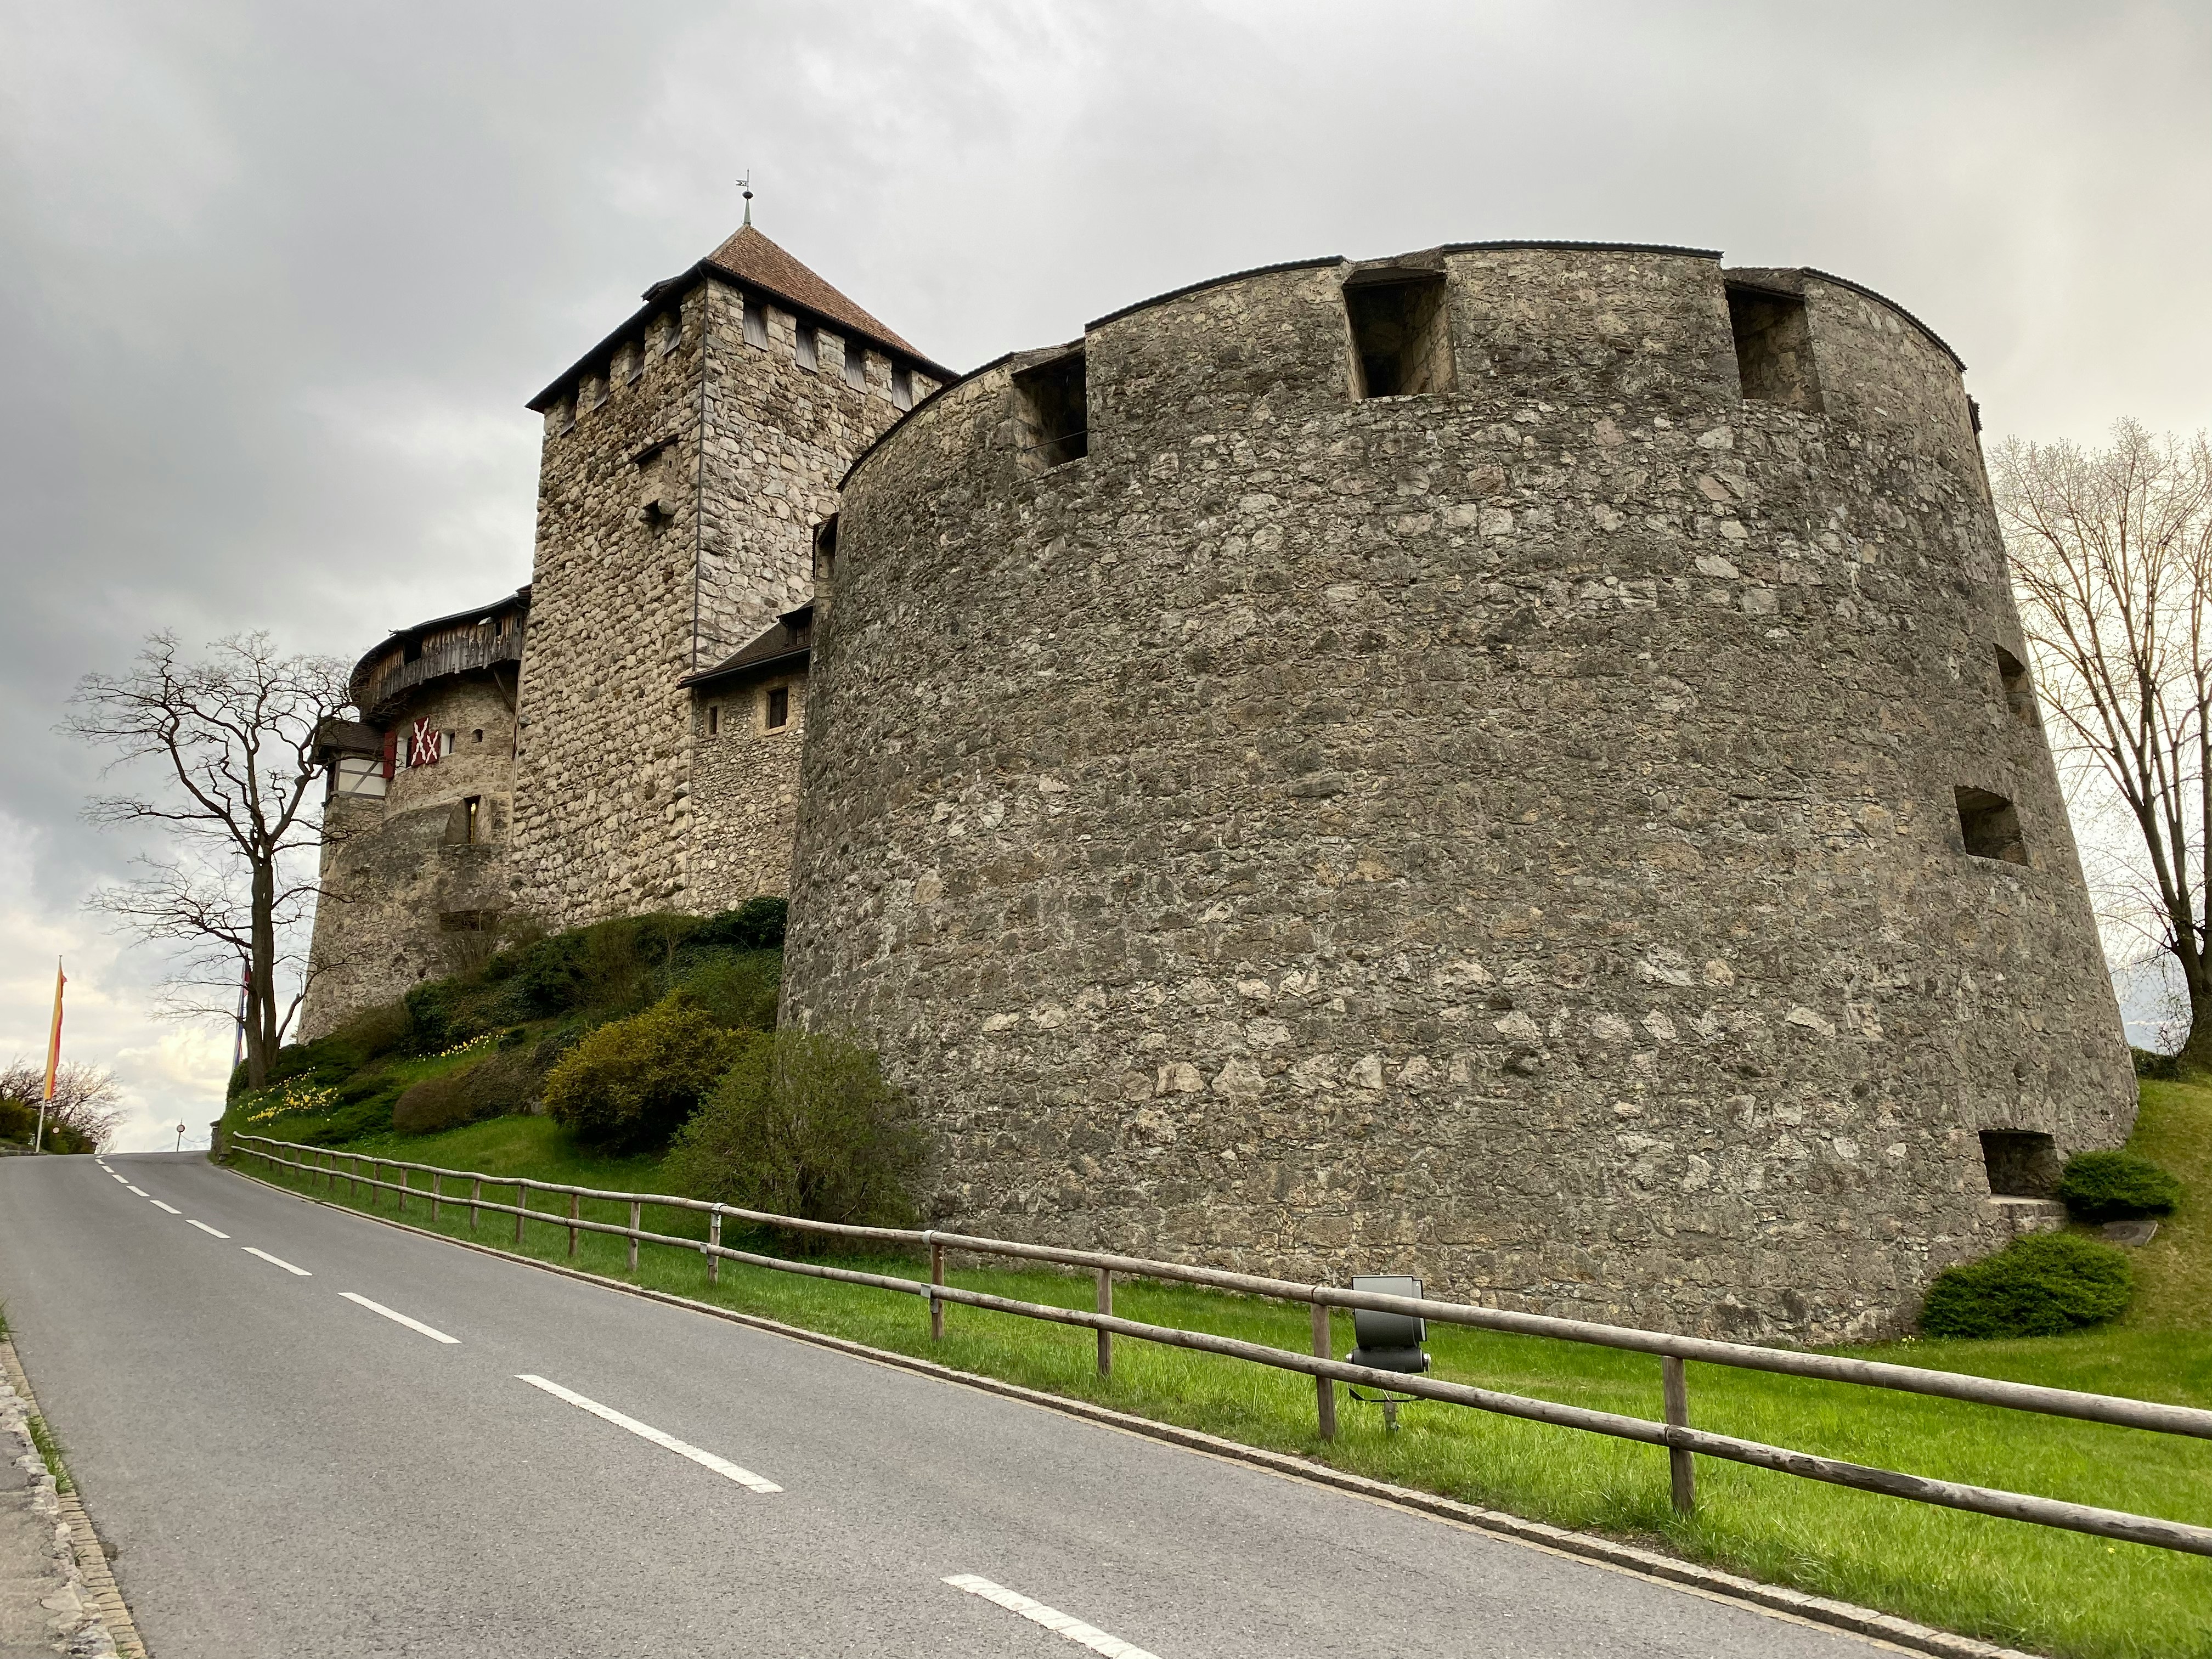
left=228, top=1135, right=2212, bottom=1555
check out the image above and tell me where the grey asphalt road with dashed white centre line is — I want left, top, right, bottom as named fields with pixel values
left=0, top=1153, right=1874, bottom=1659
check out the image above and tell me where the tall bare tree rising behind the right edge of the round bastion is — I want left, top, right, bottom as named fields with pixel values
left=1991, top=420, right=2212, bottom=1070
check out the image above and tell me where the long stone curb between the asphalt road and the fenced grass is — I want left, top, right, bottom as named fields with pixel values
left=217, top=1166, right=2037, bottom=1659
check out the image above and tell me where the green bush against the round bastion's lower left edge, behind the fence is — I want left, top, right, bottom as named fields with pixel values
left=664, top=1031, right=929, bottom=1228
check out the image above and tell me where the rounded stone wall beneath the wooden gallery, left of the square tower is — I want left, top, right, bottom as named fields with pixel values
left=298, top=668, right=515, bottom=1040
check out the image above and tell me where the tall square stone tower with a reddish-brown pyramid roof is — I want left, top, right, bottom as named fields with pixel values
left=511, top=221, right=951, bottom=927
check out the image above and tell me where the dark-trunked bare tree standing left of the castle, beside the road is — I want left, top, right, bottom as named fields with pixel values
left=62, top=633, right=352, bottom=1088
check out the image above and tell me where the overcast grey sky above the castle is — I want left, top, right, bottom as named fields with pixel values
left=0, top=0, right=2212, bottom=1146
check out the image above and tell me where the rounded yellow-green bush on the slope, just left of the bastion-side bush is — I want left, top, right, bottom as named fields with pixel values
left=544, top=991, right=743, bottom=1153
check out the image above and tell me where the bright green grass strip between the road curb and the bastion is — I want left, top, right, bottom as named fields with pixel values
left=224, top=1106, right=2212, bottom=1659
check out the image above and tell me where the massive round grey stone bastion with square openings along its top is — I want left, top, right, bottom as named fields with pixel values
left=785, top=244, right=2135, bottom=1340
